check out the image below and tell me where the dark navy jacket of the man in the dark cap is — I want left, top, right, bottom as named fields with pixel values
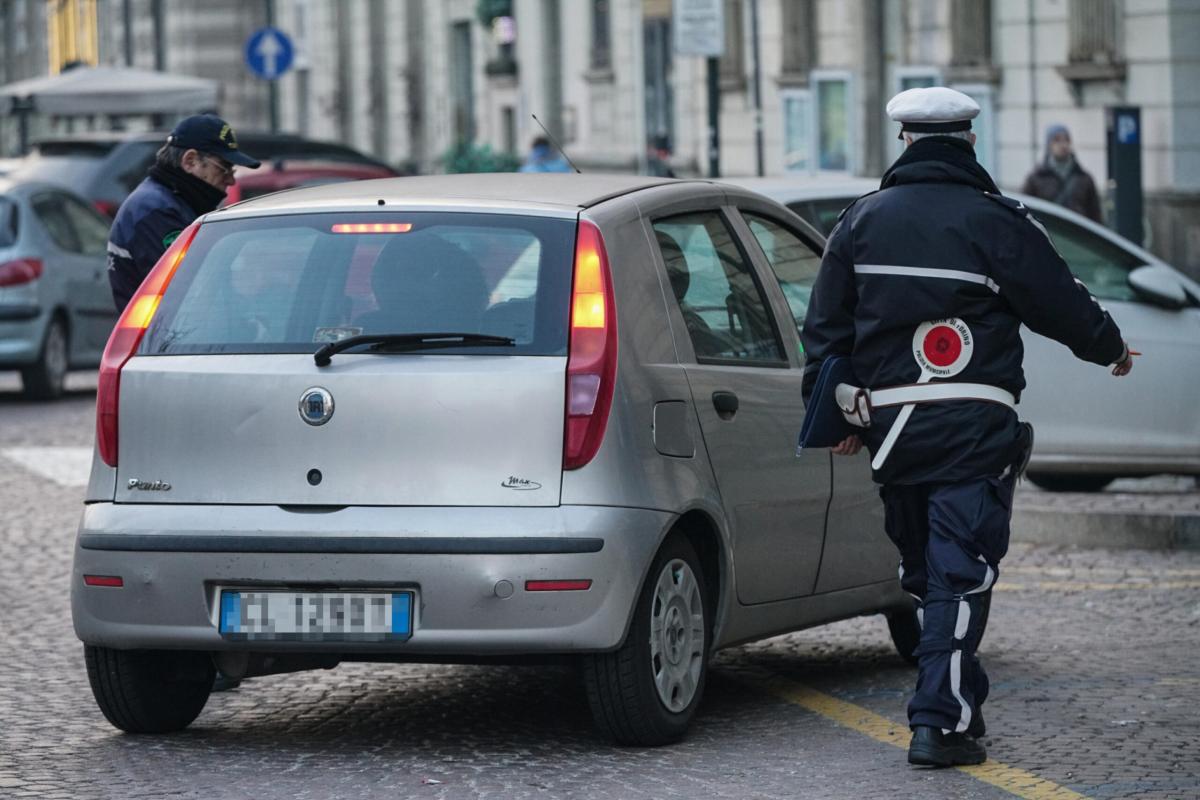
left=108, top=178, right=198, bottom=312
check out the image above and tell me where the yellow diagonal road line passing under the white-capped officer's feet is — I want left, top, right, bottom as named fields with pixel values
left=728, top=669, right=1087, bottom=800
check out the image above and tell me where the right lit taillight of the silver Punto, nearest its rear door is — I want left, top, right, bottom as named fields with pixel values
left=563, top=221, right=617, bottom=469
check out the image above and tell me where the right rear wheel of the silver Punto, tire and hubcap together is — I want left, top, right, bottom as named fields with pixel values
left=583, top=535, right=712, bottom=747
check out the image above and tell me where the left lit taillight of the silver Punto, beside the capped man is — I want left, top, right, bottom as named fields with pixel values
left=96, top=222, right=200, bottom=467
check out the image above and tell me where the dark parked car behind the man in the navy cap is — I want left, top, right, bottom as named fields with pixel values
left=13, top=131, right=398, bottom=217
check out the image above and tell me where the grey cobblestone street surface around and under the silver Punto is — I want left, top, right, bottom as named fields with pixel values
left=0, top=378, right=1200, bottom=799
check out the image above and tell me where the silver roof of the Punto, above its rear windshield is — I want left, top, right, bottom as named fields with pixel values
left=212, top=173, right=708, bottom=219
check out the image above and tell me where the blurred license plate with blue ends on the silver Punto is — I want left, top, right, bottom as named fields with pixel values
left=220, top=589, right=413, bottom=642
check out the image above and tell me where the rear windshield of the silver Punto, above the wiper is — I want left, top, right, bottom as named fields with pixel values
left=139, top=212, right=575, bottom=355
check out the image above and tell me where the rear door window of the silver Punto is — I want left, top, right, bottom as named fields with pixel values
left=654, top=211, right=785, bottom=366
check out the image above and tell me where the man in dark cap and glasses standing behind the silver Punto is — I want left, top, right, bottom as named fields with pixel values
left=108, top=114, right=259, bottom=312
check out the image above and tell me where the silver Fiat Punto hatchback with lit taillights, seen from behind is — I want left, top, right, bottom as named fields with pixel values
left=72, top=175, right=919, bottom=745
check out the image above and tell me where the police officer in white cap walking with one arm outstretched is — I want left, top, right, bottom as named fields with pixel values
left=802, top=86, right=1133, bottom=766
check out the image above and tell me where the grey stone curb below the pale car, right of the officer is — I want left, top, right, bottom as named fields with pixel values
left=1012, top=504, right=1200, bottom=551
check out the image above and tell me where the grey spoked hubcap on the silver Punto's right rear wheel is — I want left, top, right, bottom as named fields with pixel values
left=650, top=559, right=704, bottom=714
